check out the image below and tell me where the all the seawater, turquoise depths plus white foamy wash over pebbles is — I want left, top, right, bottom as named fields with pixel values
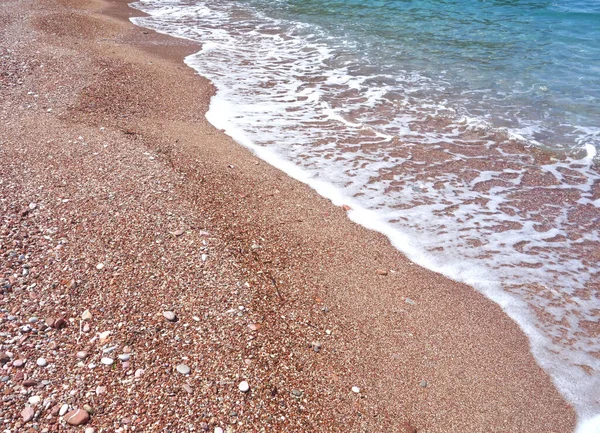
left=132, top=0, right=600, bottom=426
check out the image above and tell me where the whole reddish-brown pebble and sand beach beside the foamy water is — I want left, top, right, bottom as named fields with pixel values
left=0, top=0, right=576, bottom=433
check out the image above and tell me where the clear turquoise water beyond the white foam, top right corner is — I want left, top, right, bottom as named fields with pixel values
left=246, top=0, right=600, bottom=148
